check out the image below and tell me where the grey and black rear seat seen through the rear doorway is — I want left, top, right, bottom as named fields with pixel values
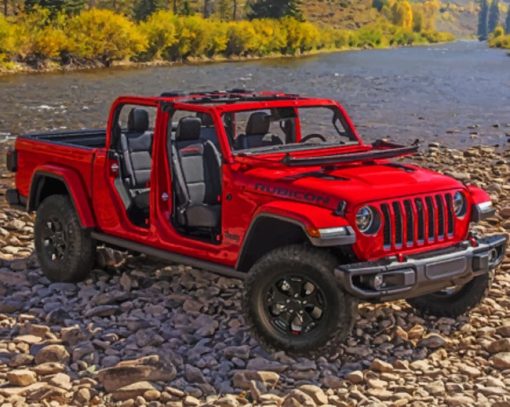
left=120, top=108, right=153, bottom=209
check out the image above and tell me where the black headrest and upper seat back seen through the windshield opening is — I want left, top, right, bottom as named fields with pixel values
left=235, top=112, right=283, bottom=150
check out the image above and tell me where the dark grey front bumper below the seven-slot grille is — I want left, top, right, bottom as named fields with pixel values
left=335, top=235, right=508, bottom=302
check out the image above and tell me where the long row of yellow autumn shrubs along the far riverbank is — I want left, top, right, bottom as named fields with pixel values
left=0, top=8, right=453, bottom=76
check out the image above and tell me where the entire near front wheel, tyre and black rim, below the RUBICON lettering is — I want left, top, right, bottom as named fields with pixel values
left=243, top=245, right=357, bottom=354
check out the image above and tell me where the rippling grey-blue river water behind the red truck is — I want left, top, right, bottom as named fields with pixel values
left=0, top=42, right=510, bottom=147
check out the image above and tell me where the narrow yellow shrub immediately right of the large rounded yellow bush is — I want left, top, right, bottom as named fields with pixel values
left=140, top=11, right=177, bottom=60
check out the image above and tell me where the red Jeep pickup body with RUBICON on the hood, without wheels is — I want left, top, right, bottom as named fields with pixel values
left=8, top=91, right=506, bottom=354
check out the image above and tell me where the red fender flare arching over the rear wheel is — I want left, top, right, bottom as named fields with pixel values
left=27, top=165, right=96, bottom=228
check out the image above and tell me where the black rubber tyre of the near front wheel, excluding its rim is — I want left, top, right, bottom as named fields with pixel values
left=243, top=245, right=357, bottom=356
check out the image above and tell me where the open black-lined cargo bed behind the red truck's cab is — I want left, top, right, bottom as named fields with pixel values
left=20, top=129, right=106, bottom=149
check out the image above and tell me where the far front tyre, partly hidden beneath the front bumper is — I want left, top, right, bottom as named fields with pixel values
left=407, top=271, right=494, bottom=318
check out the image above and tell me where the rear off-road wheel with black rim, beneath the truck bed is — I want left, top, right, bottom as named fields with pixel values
left=34, top=195, right=96, bottom=282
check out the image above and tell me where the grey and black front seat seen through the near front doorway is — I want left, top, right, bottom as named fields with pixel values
left=171, top=117, right=221, bottom=232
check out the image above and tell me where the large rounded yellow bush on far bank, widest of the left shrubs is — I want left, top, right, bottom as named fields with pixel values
left=67, top=9, right=147, bottom=66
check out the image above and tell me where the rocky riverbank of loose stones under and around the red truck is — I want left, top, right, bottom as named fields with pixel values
left=0, top=143, right=510, bottom=407
